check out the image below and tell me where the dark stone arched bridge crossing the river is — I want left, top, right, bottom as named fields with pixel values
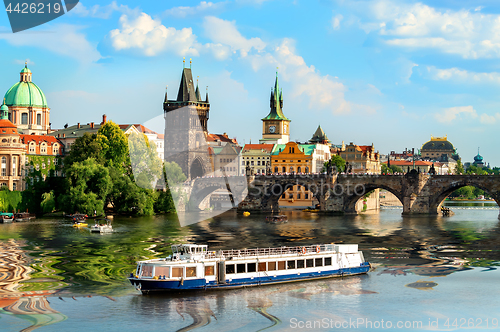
left=233, top=172, right=500, bottom=215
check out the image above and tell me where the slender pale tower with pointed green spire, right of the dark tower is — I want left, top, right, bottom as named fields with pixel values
left=260, top=72, right=290, bottom=144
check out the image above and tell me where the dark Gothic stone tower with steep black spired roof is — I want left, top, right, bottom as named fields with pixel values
left=163, top=61, right=213, bottom=179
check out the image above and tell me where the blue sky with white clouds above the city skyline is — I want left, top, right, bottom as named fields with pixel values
left=0, top=0, right=500, bottom=167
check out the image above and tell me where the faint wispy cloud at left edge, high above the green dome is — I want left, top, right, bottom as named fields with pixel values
left=0, top=24, right=101, bottom=63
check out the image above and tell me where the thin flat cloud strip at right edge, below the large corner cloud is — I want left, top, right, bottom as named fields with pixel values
left=427, top=66, right=500, bottom=83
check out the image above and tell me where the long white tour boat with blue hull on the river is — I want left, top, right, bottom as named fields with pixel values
left=128, top=244, right=370, bottom=293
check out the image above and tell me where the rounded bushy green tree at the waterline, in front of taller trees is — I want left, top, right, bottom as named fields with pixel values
left=61, top=158, right=113, bottom=214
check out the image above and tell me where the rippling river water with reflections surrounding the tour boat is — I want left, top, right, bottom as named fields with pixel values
left=0, top=201, right=500, bottom=332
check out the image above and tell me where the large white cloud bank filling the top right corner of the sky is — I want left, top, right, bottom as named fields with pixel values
left=355, top=0, right=500, bottom=59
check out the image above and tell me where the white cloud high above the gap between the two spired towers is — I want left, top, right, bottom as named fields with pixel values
left=203, top=16, right=266, bottom=57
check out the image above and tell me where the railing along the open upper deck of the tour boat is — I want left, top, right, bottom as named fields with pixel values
left=205, top=244, right=334, bottom=259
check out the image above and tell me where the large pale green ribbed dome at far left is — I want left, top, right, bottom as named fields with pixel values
left=5, top=80, right=47, bottom=107
